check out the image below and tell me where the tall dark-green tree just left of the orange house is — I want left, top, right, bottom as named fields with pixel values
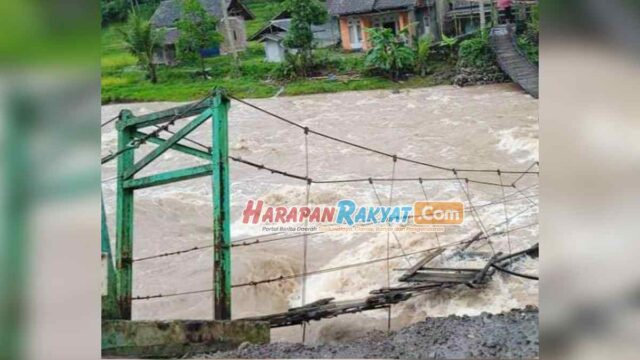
left=284, top=0, right=328, bottom=77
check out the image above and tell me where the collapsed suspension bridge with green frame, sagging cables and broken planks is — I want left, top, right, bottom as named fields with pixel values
left=102, top=89, right=538, bottom=358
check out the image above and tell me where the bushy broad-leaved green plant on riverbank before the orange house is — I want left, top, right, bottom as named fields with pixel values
left=365, top=28, right=414, bottom=81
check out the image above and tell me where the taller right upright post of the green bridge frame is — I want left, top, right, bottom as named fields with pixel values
left=211, top=90, right=231, bottom=320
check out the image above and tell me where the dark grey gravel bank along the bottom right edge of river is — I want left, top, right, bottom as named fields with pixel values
left=203, top=307, right=538, bottom=359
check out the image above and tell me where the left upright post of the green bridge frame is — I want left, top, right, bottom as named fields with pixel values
left=116, top=110, right=135, bottom=320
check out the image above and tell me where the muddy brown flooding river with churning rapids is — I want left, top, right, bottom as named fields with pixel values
left=102, top=84, right=538, bottom=342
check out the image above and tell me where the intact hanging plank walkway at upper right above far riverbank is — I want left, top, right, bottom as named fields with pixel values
left=490, top=24, right=538, bottom=99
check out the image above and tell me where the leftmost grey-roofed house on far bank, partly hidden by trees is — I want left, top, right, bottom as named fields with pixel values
left=151, top=0, right=255, bottom=65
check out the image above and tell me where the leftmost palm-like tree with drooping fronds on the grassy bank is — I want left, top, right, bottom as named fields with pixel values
left=120, top=11, right=164, bottom=84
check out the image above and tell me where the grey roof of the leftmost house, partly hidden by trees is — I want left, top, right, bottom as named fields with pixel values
left=151, top=0, right=255, bottom=27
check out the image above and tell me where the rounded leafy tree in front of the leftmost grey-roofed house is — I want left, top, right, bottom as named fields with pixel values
left=177, top=0, right=224, bottom=80
